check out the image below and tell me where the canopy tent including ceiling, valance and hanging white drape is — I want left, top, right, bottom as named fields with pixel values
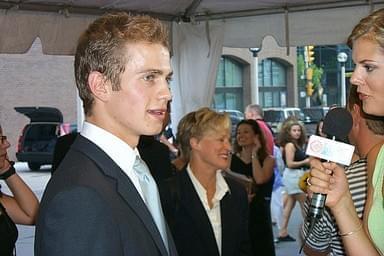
left=0, top=0, right=384, bottom=126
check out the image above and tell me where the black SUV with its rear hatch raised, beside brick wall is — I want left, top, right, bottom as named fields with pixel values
left=15, top=107, right=63, bottom=170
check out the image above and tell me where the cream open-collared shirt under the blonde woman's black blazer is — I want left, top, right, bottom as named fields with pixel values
left=187, top=164, right=229, bottom=255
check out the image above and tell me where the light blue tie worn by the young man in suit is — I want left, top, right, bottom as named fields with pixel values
left=133, top=156, right=169, bottom=252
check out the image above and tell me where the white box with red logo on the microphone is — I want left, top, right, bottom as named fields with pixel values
left=306, top=135, right=355, bottom=165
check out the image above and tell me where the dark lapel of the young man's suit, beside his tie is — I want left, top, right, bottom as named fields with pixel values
left=72, top=136, right=173, bottom=255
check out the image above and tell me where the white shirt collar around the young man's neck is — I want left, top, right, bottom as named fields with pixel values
left=80, top=122, right=145, bottom=201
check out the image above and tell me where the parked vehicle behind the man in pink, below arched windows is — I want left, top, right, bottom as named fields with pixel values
left=263, top=107, right=305, bottom=135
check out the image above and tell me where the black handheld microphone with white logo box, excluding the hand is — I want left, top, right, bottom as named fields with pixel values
left=307, top=107, right=354, bottom=221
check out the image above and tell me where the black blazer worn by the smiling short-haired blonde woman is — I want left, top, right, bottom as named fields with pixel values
left=160, top=169, right=250, bottom=256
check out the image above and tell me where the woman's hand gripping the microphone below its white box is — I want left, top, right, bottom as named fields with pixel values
left=308, top=159, right=351, bottom=209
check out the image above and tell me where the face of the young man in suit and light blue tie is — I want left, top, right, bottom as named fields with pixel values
left=103, top=42, right=172, bottom=146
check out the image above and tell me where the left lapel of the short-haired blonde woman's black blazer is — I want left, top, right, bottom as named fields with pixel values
left=180, top=170, right=219, bottom=255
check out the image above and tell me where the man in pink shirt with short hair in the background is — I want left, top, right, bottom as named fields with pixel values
left=244, top=104, right=275, bottom=155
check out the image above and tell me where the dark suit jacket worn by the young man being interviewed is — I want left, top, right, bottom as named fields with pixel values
left=35, top=135, right=177, bottom=256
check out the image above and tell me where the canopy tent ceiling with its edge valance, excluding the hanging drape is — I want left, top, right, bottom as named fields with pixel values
left=0, top=0, right=384, bottom=55
